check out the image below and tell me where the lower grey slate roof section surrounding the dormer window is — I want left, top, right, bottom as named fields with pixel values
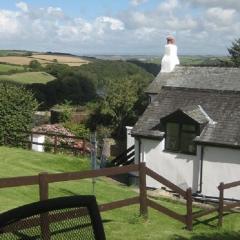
left=132, top=87, right=240, bottom=147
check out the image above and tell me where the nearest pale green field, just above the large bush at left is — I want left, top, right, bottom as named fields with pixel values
left=0, top=72, right=55, bottom=84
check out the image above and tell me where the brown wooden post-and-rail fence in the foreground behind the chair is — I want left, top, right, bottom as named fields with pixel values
left=0, top=163, right=240, bottom=231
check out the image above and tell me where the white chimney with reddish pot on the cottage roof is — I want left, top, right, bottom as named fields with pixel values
left=161, top=36, right=180, bottom=73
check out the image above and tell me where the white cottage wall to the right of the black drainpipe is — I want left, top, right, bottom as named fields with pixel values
left=202, top=147, right=240, bottom=199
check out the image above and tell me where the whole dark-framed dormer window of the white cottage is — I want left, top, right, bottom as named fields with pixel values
left=165, top=123, right=197, bottom=154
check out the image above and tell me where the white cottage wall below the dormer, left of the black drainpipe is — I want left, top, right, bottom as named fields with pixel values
left=141, top=139, right=200, bottom=192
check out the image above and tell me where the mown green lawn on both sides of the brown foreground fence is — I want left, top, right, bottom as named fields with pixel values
left=0, top=147, right=240, bottom=240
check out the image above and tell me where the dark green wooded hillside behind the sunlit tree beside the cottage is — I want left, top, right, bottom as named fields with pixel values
left=26, top=60, right=153, bottom=109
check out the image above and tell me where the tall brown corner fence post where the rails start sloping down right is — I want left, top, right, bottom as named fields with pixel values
left=139, top=162, right=148, bottom=219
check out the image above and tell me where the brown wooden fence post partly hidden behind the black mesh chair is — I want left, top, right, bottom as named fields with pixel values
left=38, top=173, right=51, bottom=240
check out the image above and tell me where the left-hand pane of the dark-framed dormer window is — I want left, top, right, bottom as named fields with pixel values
left=166, top=123, right=179, bottom=151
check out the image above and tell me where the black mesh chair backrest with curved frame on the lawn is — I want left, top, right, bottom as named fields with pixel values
left=0, top=196, right=105, bottom=240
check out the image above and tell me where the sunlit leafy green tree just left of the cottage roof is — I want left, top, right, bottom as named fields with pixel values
left=88, top=75, right=150, bottom=139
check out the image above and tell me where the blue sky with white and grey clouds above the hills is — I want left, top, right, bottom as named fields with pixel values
left=0, top=0, right=240, bottom=55
